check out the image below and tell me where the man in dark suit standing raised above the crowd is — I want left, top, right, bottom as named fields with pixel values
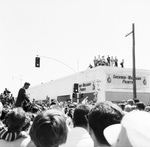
left=15, top=82, right=30, bottom=107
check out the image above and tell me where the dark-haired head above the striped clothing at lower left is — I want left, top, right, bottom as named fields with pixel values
left=6, top=107, right=26, bottom=131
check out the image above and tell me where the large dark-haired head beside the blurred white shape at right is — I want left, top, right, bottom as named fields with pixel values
left=87, top=101, right=124, bottom=145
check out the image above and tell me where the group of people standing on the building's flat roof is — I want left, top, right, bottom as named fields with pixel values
left=89, top=55, right=124, bottom=68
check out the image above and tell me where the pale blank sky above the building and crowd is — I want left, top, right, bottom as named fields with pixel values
left=0, top=0, right=150, bottom=96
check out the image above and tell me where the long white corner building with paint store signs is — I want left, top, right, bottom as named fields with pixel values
left=28, top=66, right=150, bottom=104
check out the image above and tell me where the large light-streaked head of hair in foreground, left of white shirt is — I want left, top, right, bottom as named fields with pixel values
left=30, top=109, right=68, bottom=147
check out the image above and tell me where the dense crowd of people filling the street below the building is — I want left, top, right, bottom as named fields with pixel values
left=0, top=83, right=150, bottom=147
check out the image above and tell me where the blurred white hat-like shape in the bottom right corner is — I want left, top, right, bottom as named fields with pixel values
left=104, top=110, right=150, bottom=147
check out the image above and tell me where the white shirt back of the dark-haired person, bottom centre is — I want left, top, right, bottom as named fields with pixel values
left=60, top=127, right=94, bottom=147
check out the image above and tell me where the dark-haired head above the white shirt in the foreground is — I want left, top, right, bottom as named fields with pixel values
left=73, top=104, right=90, bottom=127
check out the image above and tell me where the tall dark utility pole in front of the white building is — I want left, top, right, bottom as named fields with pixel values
left=126, top=23, right=137, bottom=99
